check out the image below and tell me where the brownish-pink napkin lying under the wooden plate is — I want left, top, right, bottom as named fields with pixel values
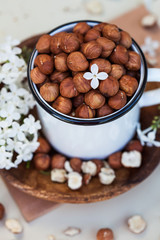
left=2, top=3, right=160, bottom=221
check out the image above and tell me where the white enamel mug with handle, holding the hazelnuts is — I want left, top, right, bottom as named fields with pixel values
left=28, top=21, right=160, bottom=160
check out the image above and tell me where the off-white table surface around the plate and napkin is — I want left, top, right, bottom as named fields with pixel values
left=0, top=0, right=160, bottom=240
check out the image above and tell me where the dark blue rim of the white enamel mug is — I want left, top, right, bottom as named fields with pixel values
left=27, top=20, right=147, bottom=126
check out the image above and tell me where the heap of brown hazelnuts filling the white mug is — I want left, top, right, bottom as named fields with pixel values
left=30, top=22, right=141, bottom=118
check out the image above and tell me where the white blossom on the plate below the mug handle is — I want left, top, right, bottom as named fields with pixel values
left=137, top=123, right=160, bottom=147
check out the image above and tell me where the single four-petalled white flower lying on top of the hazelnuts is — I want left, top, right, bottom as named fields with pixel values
left=83, top=64, right=108, bottom=89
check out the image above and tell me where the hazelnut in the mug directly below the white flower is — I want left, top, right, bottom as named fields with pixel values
left=84, top=90, right=105, bottom=109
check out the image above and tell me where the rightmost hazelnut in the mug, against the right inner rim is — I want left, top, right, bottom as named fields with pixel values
left=125, top=51, right=141, bottom=71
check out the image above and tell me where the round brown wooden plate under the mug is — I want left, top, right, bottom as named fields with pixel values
left=0, top=35, right=160, bottom=203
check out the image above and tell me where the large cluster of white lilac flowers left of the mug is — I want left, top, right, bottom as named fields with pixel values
left=0, top=37, right=41, bottom=170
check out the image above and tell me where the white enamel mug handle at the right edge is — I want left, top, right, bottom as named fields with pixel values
left=139, top=68, right=160, bottom=108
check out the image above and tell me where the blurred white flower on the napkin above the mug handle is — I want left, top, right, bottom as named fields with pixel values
left=141, top=36, right=160, bottom=57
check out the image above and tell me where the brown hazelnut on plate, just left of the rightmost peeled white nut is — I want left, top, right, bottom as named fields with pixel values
left=108, top=152, right=122, bottom=169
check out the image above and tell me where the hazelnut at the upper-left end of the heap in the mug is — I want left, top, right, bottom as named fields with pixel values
left=36, top=34, right=52, bottom=53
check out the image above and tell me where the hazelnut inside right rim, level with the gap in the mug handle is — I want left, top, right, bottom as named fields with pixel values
left=119, top=75, right=138, bottom=97
